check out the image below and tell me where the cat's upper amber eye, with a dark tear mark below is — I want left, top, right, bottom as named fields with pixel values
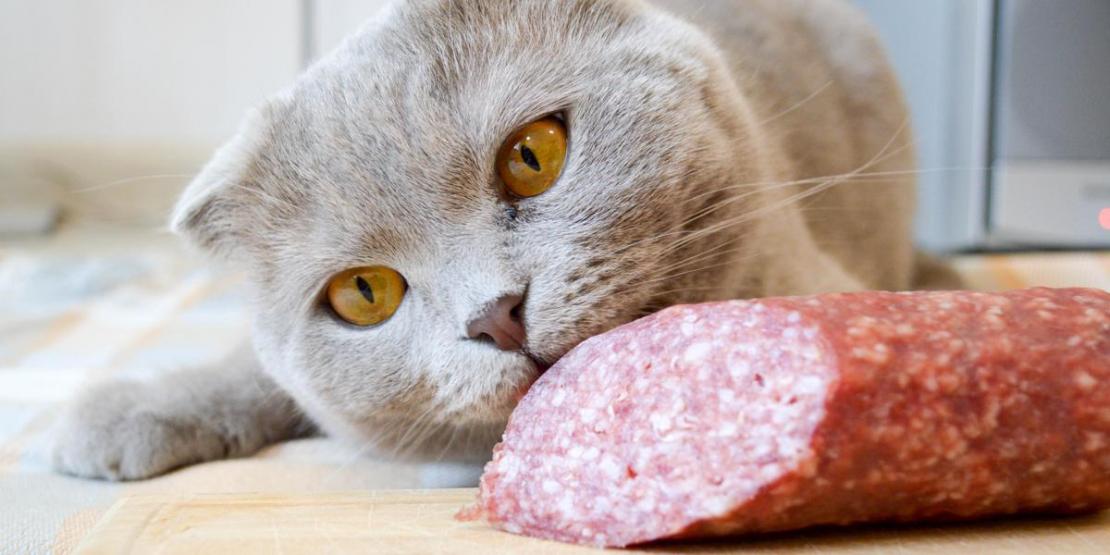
left=497, top=118, right=567, bottom=199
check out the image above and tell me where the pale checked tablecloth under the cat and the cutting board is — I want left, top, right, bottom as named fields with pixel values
left=0, top=231, right=1110, bottom=554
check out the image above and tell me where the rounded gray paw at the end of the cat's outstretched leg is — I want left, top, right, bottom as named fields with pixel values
left=50, top=382, right=226, bottom=481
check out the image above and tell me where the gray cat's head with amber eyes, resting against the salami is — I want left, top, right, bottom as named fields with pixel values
left=173, top=0, right=755, bottom=456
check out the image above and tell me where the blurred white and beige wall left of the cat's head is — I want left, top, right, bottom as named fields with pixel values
left=0, top=0, right=384, bottom=232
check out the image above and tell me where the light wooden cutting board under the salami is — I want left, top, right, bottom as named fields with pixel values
left=78, top=490, right=1110, bottom=555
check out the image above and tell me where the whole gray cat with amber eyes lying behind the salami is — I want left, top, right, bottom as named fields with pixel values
left=52, top=0, right=948, bottom=480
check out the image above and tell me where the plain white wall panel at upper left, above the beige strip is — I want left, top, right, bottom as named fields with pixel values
left=0, top=0, right=302, bottom=144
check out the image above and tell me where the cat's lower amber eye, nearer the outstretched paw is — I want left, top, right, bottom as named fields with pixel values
left=327, top=266, right=407, bottom=327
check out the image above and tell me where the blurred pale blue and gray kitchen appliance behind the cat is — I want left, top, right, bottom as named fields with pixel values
left=857, top=0, right=1110, bottom=251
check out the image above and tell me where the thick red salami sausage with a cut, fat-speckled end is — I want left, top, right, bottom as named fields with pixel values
left=461, top=289, right=1110, bottom=546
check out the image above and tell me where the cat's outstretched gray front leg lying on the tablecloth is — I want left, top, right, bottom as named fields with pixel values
left=51, top=349, right=311, bottom=481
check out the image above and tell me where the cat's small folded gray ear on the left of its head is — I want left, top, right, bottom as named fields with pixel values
left=170, top=104, right=284, bottom=258
